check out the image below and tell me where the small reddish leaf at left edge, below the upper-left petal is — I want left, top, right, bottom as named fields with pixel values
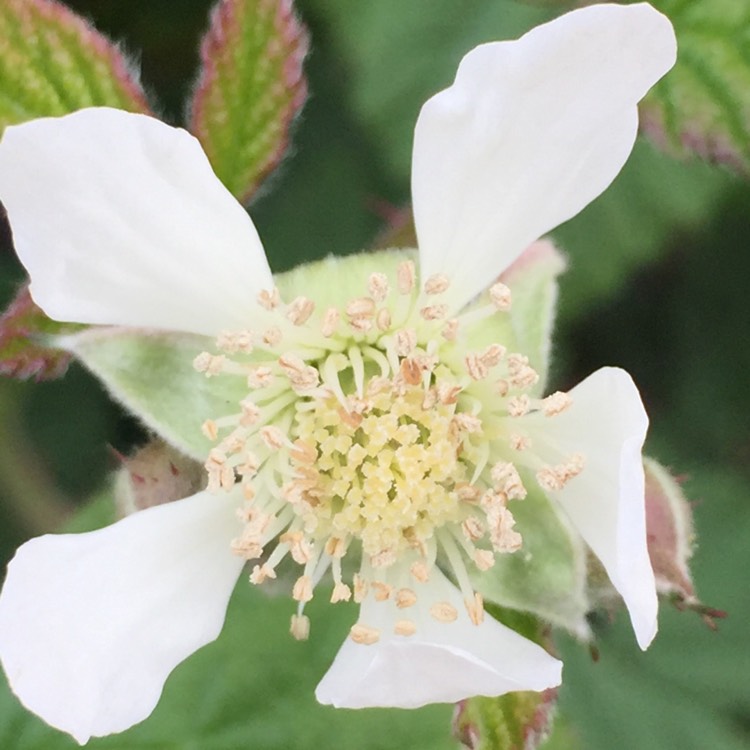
left=0, top=285, right=82, bottom=381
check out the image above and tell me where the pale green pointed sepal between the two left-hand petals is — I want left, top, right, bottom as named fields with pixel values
left=63, top=328, right=247, bottom=461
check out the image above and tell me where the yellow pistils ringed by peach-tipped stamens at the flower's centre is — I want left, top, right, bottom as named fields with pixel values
left=194, top=259, right=584, bottom=643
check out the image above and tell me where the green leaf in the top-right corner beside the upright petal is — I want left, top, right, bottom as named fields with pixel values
left=641, top=0, right=750, bottom=174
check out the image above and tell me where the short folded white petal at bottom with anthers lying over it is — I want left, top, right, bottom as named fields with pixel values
left=315, top=570, right=562, bottom=708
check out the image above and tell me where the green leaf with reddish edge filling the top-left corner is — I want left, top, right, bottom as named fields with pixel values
left=0, top=0, right=149, bottom=131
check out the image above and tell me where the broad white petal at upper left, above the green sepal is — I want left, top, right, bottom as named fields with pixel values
left=0, top=108, right=272, bottom=335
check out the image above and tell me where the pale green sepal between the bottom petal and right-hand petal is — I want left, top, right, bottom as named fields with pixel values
left=472, top=490, right=590, bottom=640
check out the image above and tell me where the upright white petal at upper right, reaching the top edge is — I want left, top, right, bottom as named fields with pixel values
left=412, top=3, right=675, bottom=307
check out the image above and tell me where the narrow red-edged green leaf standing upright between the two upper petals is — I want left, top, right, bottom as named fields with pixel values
left=189, top=0, right=308, bottom=202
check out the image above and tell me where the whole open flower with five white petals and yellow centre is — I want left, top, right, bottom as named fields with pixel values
left=0, top=4, right=675, bottom=743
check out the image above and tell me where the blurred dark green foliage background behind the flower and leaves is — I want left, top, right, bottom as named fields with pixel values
left=0, top=0, right=750, bottom=750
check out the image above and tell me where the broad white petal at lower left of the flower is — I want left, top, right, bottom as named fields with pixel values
left=0, top=493, right=242, bottom=744
